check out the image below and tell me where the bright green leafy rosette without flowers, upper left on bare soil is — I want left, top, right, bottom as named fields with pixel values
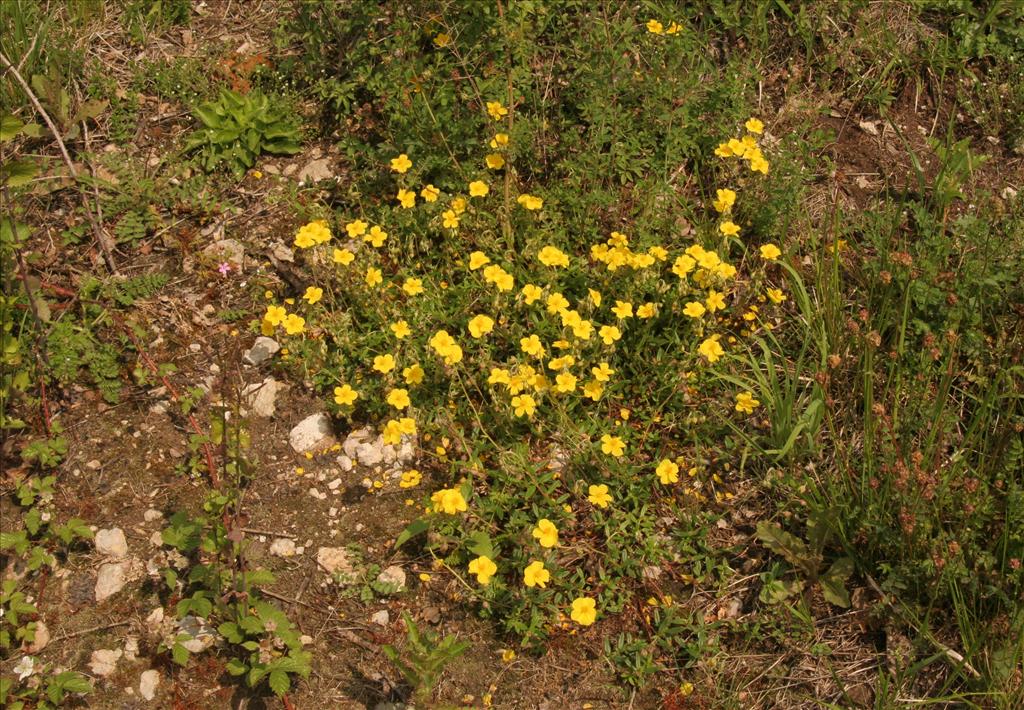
left=185, top=89, right=301, bottom=174
